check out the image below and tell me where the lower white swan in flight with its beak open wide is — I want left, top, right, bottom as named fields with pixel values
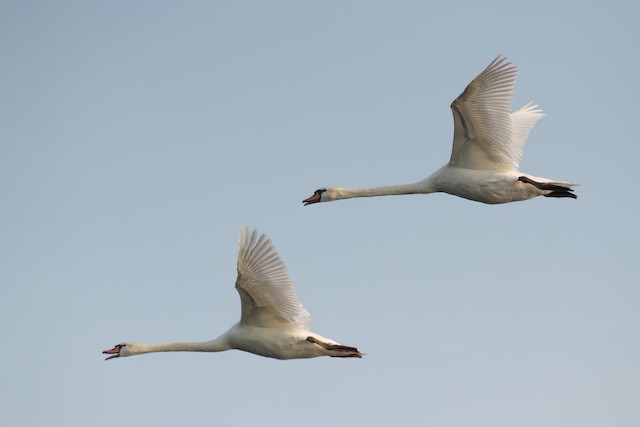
left=102, top=227, right=363, bottom=360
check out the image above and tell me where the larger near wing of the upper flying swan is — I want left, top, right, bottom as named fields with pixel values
left=449, top=56, right=522, bottom=170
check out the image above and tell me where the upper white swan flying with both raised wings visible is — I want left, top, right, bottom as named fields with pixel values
left=302, top=56, right=577, bottom=206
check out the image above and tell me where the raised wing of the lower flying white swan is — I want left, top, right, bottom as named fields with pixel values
left=236, top=227, right=310, bottom=328
